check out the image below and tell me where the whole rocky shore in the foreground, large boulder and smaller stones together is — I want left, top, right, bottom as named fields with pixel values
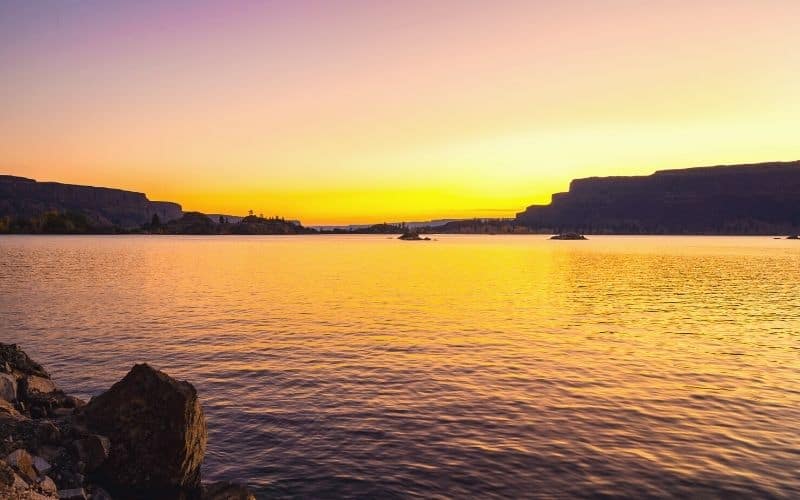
left=0, top=343, right=255, bottom=500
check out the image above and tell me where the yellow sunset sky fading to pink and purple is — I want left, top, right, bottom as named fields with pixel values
left=0, top=0, right=800, bottom=224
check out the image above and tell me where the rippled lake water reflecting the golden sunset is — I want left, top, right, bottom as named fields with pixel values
left=0, top=236, right=800, bottom=498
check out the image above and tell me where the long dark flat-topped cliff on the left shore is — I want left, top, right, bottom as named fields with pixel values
left=0, top=175, right=183, bottom=228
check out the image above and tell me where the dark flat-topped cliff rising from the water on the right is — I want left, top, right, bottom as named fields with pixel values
left=517, top=161, right=800, bottom=234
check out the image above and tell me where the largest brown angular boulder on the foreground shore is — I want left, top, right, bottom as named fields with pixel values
left=80, top=364, right=206, bottom=497
